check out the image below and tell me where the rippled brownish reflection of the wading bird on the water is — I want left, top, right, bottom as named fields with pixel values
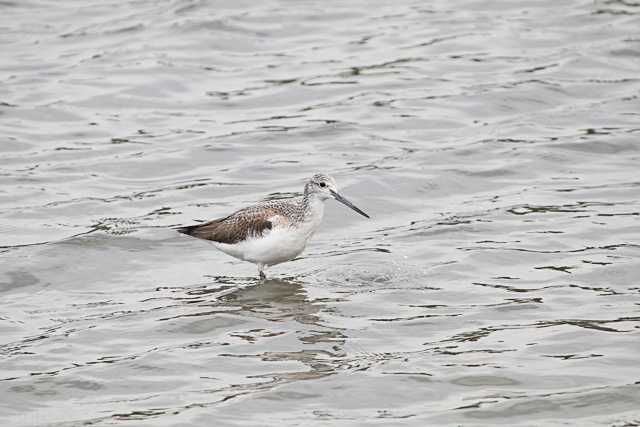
left=165, top=276, right=348, bottom=363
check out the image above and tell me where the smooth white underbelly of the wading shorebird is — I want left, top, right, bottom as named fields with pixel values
left=214, top=227, right=312, bottom=265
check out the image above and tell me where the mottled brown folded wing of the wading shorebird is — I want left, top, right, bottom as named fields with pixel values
left=178, top=211, right=273, bottom=244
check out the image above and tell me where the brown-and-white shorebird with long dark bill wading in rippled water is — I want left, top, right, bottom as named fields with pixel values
left=177, top=174, right=369, bottom=279
